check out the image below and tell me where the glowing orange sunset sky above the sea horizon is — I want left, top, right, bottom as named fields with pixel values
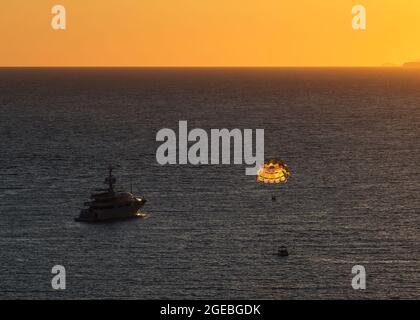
left=0, top=0, right=420, bottom=66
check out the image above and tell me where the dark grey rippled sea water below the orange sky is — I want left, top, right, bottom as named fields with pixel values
left=0, top=69, right=420, bottom=299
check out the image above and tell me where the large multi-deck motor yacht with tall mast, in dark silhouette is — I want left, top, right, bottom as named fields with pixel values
left=74, top=167, right=146, bottom=222
